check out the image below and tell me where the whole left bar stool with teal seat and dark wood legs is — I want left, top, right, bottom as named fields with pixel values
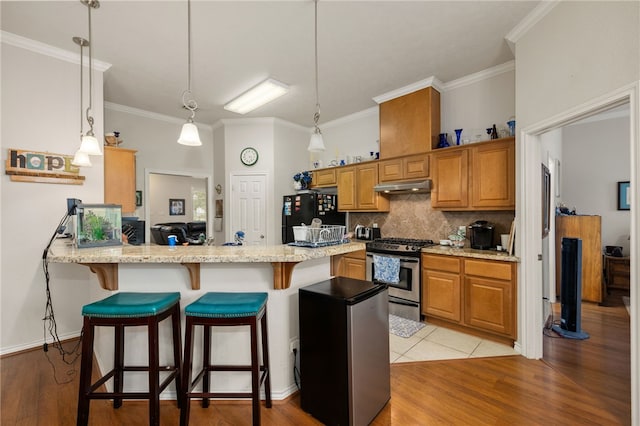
left=77, top=292, right=182, bottom=425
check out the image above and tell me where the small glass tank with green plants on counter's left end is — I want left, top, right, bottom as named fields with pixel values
left=76, top=204, right=122, bottom=248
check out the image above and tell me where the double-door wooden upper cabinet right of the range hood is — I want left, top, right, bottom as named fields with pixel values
left=431, top=138, right=515, bottom=210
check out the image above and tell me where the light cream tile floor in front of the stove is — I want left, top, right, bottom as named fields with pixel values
left=389, top=323, right=518, bottom=364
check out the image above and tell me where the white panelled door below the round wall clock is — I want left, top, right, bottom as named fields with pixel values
left=229, top=174, right=267, bottom=246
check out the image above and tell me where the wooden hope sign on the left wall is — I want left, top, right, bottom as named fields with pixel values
left=5, top=148, right=84, bottom=185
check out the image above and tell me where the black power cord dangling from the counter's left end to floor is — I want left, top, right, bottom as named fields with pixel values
left=42, top=211, right=84, bottom=385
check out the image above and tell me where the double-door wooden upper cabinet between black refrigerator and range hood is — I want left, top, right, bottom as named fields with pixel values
left=337, top=162, right=389, bottom=212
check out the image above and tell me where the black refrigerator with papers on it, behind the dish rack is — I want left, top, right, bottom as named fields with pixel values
left=282, top=192, right=346, bottom=244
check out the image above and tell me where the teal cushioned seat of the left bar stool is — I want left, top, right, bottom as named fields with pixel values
left=82, top=292, right=180, bottom=318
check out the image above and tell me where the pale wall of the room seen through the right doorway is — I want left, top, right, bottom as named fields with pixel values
left=560, top=117, right=631, bottom=251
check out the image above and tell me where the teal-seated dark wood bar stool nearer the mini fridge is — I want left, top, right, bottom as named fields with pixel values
left=180, top=293, right=271, bottom=426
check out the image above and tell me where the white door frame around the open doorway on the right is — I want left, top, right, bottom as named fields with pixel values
left=516, top=84, right=640, bottom=422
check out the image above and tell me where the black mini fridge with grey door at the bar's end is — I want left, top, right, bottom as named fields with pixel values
left=298, top=277, right=391, bottom=425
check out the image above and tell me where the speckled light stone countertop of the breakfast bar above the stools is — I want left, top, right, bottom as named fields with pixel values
left=47, top=241, right=365, bottom=263
